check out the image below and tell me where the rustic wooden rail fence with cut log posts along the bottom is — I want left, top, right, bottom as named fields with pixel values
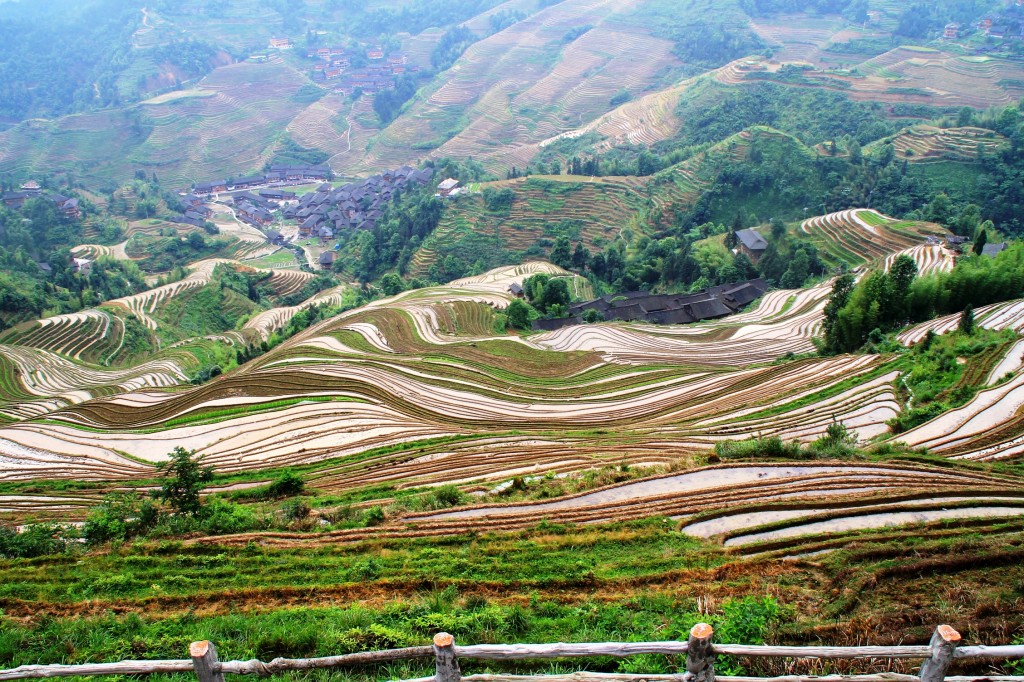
left=0, top=623, right=1024, bottom=682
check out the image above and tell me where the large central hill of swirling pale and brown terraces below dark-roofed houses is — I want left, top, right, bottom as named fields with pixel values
left=0, top=225, right=1017, bottom=475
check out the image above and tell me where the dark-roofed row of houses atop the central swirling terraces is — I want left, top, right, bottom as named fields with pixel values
left=528, top=279, right=768, bottom=331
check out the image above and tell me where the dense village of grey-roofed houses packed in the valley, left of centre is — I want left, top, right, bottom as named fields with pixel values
left=282, top=166, right=433, bottom=240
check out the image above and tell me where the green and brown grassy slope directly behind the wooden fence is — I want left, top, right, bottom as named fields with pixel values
left=0, top=519, right=1024, bottom=679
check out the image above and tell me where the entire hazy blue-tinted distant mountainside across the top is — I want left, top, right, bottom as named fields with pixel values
left=0, top=0, right=1024, bottom=186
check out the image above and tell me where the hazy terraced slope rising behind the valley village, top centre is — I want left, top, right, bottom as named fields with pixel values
left=339, top=0, right=678, bottom=174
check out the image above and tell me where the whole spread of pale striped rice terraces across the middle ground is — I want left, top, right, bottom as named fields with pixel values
left=0, top=200, right=1024, bottom=540
